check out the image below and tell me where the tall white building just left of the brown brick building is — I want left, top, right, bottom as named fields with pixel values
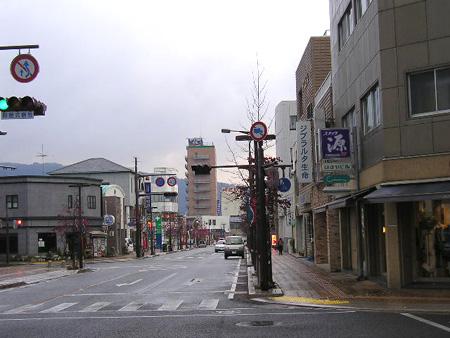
left=275, top=101, right=303, bottom=252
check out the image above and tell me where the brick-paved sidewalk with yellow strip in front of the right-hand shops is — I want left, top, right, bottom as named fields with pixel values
left=249, top=252, right=450, bottom=313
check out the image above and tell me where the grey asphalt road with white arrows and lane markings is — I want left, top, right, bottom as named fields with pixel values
left=0, top=247, right=450, bottom=338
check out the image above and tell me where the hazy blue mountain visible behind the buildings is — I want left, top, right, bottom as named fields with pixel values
left=0, top=162, right=233, bottom=215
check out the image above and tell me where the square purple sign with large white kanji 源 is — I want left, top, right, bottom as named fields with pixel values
left=319, top=128, right=351, bottom=159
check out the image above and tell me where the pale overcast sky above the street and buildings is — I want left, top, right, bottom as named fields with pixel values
left=0, top=0, right=329, bottom=181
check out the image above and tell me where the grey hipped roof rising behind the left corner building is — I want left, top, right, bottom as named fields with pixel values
left=48, top=158, right=132, bottom=175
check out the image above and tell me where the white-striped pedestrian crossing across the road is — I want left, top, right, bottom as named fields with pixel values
left=0, top=298, right=224, bottom=315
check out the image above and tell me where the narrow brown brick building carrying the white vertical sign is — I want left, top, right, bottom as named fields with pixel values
left=295, top=36, right=334, bottom=270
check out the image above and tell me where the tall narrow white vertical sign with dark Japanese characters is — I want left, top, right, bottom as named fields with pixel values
left=297, top=121, right=313, bottom=183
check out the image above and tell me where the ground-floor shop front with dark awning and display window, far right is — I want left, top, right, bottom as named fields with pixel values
left=366, top=181, right=450, bottom=288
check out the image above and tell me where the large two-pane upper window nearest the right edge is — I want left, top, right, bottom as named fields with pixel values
left=408, top=68, right=450, bottom=116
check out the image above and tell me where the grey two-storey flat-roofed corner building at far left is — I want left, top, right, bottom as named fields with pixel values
left=0, top=176, right=102, bottom=259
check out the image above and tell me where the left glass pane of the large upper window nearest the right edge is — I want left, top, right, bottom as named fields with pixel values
left=409, top=71, right=436, bottom=115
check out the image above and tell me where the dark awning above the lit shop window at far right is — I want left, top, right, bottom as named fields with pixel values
left=364, top=181, right=450, bottom=203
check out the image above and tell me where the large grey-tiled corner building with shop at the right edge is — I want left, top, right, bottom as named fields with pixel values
left=326, top=0, right=450, bottom=288
